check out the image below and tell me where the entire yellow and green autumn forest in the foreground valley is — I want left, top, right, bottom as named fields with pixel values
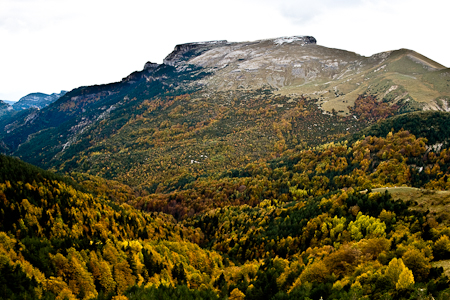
left=0, top=123, right=450, bottom=300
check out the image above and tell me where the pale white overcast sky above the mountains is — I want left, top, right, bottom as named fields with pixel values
left=0, top=0, right=450, bottom=101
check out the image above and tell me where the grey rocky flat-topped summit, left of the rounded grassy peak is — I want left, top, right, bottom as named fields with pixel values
left=164, top=36, right=365, bottom=90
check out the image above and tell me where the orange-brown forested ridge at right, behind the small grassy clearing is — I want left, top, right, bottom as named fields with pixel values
left=98, top=126, right=450, bottom=218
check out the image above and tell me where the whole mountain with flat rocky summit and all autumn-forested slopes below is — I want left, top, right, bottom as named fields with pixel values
left=0, top=37, right=450, bottom=300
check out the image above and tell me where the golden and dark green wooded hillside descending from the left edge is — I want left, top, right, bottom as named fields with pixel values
left=0, top=156, right=222, bottom=299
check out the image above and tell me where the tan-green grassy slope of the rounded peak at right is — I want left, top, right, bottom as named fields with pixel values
left=292, top=49, right=450, bottom=115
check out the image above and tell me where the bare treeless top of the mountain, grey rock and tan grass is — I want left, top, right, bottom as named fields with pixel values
left=164, top=37, right=449, bottom=113
